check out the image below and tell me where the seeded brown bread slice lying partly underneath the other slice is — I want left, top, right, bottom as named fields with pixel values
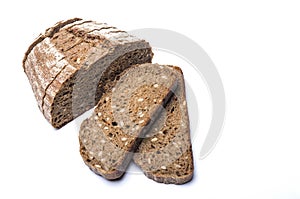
left=133, top=68, right=194, bottom=184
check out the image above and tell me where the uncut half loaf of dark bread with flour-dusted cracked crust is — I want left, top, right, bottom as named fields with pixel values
left=23, top=18, right=153, bottom=128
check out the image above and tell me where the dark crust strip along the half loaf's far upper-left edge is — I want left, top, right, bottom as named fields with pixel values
left=22, top=18, right=82, bottom=70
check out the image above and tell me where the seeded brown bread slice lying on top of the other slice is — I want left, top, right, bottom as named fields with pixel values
left=79, top=64, right=178, bottom=179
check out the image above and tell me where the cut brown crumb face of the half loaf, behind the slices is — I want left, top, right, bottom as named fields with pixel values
left=51, top=48, right=152, bottom=128
